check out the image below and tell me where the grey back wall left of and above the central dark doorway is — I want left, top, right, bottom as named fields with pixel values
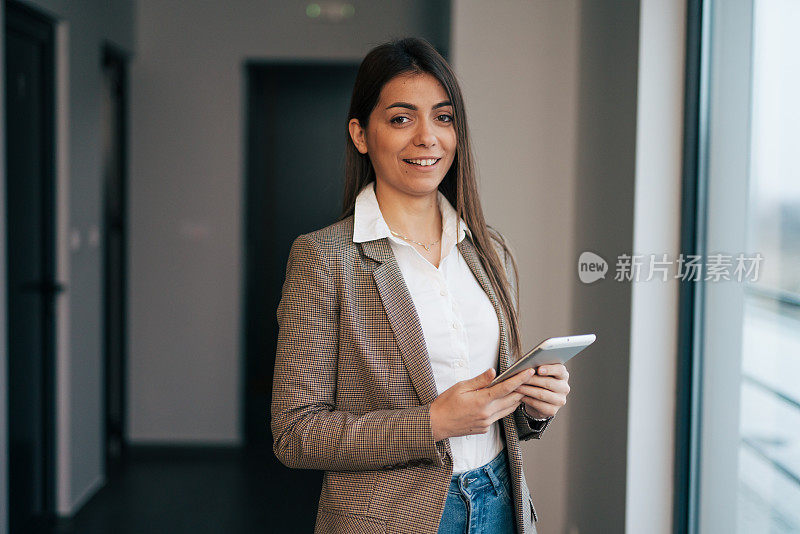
left=128, top=0, right=447, bottom=444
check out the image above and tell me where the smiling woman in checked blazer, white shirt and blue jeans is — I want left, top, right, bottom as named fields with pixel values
left=272, top=38, right=569, bottom=534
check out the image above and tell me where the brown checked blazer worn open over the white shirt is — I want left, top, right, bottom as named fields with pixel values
left=272, top=215, right=549, bottom=534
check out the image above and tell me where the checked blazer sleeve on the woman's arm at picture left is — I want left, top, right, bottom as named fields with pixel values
left=271, top=234, right=446, bottom=471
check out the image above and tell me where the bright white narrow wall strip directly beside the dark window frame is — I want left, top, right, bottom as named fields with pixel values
left=625, top=0, right=686, bottom=534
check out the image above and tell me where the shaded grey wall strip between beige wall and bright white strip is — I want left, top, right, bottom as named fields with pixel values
left=567, top=0, right=640, bottom=534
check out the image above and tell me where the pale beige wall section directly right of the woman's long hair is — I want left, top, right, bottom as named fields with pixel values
left=451, top=0, right=579, bottom=533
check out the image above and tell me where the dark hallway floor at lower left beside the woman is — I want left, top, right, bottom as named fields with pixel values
left=39, top=448, right=322, bottom=534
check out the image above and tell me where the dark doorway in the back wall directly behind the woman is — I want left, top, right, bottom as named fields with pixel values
left=244, top=63, right=358, bottom=532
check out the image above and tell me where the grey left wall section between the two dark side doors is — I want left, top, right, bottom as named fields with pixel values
left=0, top=0, right=134, bottom=521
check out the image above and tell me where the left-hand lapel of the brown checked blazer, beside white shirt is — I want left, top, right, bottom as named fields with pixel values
left=361, top=237, right=437, bottom=404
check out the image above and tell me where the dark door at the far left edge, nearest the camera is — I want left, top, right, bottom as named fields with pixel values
left=5, top=1, right=62, bottom=534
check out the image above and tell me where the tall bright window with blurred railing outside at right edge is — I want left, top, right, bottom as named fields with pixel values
left=688, top=0, right=800, bottom=534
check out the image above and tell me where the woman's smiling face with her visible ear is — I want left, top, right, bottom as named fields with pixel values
left=349, top=73, right=456, bottom=200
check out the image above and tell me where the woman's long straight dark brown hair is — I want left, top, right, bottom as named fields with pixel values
left=340, top=37, right=520, bottom=360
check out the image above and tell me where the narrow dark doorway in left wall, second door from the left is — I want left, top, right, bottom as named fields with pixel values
left=102, top=46, right=128, bottom=475
